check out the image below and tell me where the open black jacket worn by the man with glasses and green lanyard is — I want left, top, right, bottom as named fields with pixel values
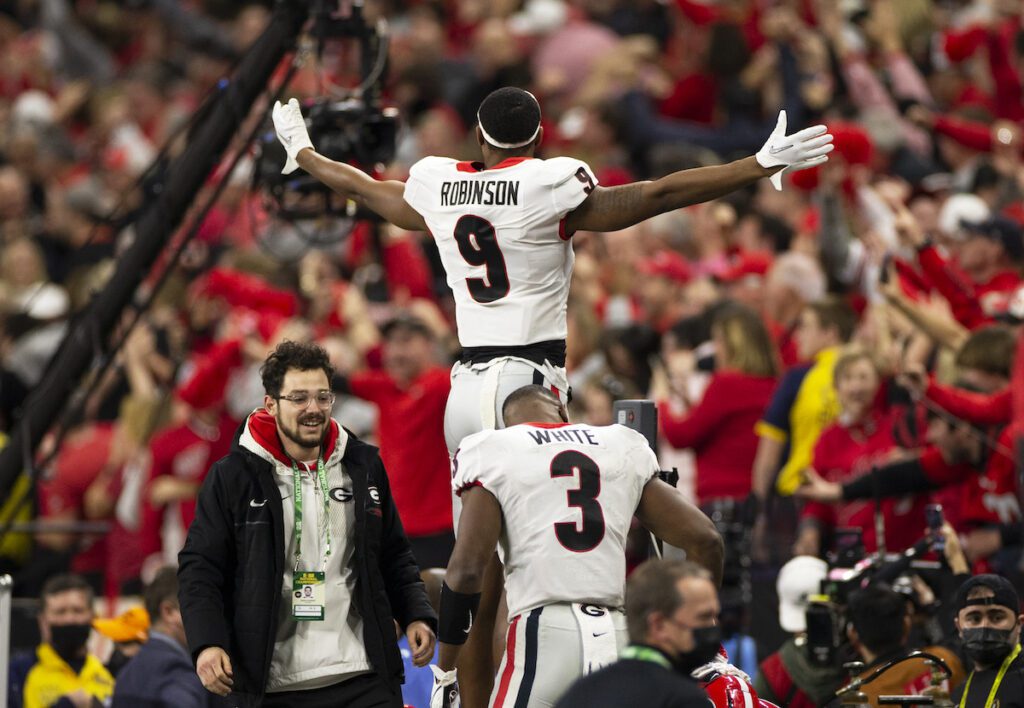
left=178, top=423, right=437, bottom=704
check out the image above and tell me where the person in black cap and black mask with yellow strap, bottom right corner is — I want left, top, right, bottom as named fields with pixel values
left=952, top=575, right=1024, bottom=708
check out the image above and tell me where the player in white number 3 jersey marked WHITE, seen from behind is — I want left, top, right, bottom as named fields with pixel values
left=432, top=386, right=722, bottom=708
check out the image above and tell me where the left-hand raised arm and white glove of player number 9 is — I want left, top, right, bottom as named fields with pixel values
left=273, top=98, right=427, bottom=231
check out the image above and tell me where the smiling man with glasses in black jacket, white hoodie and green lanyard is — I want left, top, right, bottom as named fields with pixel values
left=178, top=342, right=436, bottom=708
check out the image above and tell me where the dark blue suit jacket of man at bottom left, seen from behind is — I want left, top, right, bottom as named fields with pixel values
left=113, top=632, right=215, bottom=708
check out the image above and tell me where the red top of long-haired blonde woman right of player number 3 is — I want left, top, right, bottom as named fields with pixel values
left=660, top=371, right=775, bottom=504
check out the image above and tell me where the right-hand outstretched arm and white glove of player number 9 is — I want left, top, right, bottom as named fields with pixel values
left=565, top=111, right=833, bottom=234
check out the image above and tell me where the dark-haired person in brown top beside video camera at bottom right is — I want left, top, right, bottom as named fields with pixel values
left=846, top=583, right=973, bottom=706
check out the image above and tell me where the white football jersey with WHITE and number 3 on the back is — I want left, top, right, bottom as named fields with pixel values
left=452, top=423, right=658, bottom=617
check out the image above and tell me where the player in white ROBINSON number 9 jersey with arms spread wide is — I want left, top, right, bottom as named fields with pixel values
left=273, top=88, right=833, bottom=452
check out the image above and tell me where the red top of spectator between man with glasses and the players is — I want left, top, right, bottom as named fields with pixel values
left=349, top=367, right=452, bottom=537
